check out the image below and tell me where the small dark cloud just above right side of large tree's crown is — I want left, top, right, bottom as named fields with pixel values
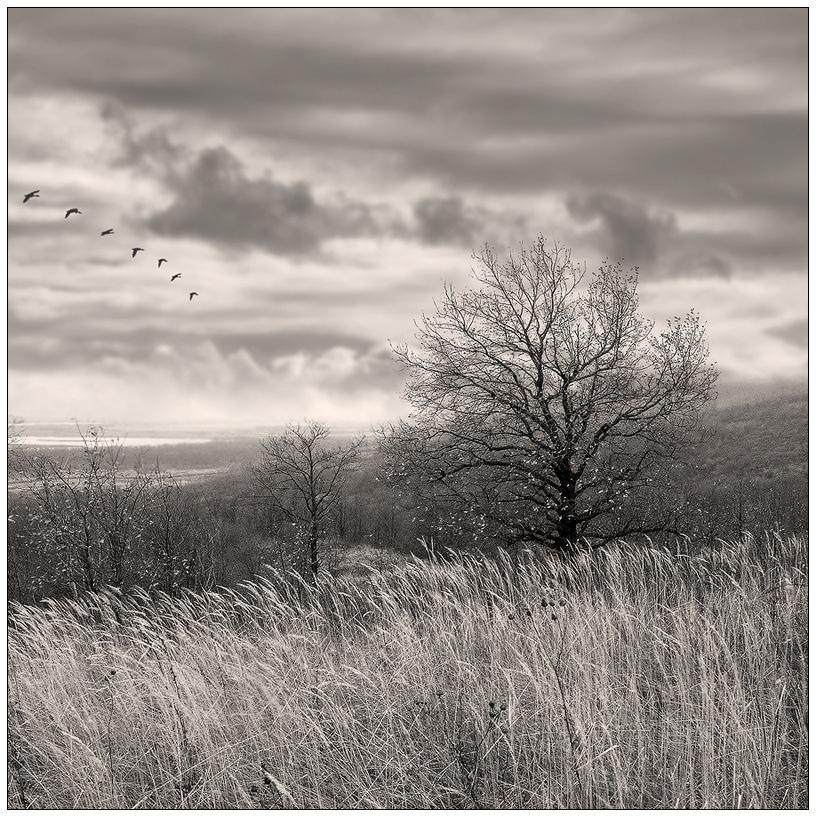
left=566, top=192, right=677, bottom=266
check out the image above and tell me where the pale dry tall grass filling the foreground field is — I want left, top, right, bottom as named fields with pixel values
left=9, top=538, right=807, bottom=808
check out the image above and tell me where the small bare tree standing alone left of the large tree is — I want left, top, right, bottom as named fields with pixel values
left=253, top=422, right=365, bottom=577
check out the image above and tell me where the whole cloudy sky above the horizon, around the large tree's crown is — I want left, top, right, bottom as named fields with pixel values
left=8, top=9, right=807, bottom=427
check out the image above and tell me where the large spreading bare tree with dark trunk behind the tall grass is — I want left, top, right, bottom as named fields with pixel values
left=382, top=237, right=717, bottom=553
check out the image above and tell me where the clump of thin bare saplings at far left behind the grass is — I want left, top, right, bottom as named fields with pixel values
left=15, top=428, right=215, bottom=597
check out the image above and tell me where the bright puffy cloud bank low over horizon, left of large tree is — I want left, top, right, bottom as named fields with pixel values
left=9, top=341, right=401, bottom=430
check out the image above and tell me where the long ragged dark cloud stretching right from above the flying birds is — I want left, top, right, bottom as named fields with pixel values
left=102, top=104, right=526, bottom=256
